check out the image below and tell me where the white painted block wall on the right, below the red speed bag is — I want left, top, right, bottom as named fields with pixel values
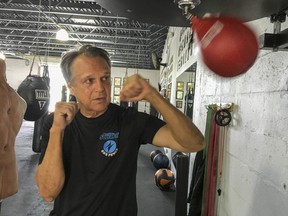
left=163, top=18, right=288, bottom=216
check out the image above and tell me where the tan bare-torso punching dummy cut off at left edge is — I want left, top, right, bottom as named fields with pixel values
left=0, top=58, right=26, bottom=211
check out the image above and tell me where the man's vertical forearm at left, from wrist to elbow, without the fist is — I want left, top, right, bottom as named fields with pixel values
left=36, top=128, right=65, bottom=202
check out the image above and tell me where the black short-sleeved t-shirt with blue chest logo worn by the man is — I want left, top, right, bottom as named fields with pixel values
left=40, top=104, right=165, bottom=216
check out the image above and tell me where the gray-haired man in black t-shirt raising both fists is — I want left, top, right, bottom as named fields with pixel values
left=35, top=45, right=204, bottom=216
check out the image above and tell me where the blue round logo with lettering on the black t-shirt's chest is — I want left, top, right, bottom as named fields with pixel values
left=100, top=132, right=119, bottom=157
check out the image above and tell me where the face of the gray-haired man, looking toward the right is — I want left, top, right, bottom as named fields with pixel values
left=68, top=55, right=111, bottom=117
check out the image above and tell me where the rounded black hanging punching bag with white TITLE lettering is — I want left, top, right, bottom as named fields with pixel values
left=17, top=75, right=50, bottom=121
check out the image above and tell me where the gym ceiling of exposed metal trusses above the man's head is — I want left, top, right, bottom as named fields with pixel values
left=0, top=0, right=168, bottom=69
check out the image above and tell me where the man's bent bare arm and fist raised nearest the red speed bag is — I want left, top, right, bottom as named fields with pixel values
left=120, top=74, right=204, bottom=152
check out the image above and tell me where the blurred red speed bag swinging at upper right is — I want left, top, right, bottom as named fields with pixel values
left=191, top=16, right=259, bottom=77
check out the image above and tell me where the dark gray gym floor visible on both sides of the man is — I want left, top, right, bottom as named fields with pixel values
left=0, top=121, right=175, bottom=216
